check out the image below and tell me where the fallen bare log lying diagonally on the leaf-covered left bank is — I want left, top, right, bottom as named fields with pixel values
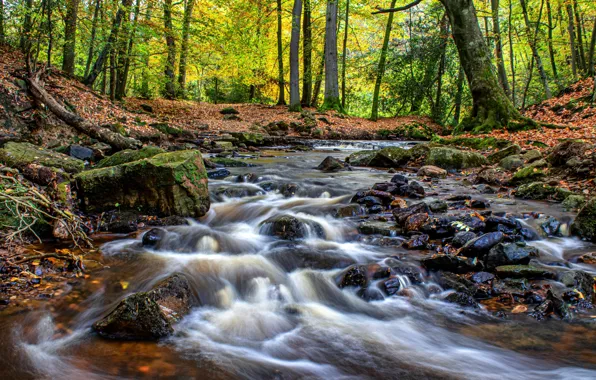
left=26, top=70, right=142, bottom=150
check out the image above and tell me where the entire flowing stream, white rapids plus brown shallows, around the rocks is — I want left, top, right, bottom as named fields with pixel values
left=0, top=144, right=596, bottom=379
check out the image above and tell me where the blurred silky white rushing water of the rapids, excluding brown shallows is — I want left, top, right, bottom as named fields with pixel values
left=7, top=147, right=596, bottom=379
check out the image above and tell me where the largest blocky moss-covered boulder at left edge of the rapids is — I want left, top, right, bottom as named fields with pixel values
left=75, top=150, right=210, bottom=217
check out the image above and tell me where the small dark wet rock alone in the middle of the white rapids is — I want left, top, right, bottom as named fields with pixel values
left=260, top=215, right=325, bottom=240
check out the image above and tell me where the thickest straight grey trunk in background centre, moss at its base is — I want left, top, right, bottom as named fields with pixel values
left=322, top=0, right=343, bottom=112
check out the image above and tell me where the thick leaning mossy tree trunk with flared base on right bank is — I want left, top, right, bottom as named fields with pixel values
left=441, top=0, right=520, bottom=132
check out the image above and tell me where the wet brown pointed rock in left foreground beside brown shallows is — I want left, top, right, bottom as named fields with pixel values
left=93, top=274, right=193, bottom=340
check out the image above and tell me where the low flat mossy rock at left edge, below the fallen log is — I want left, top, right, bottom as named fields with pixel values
left=0, top=142, right=85, bottom=173
